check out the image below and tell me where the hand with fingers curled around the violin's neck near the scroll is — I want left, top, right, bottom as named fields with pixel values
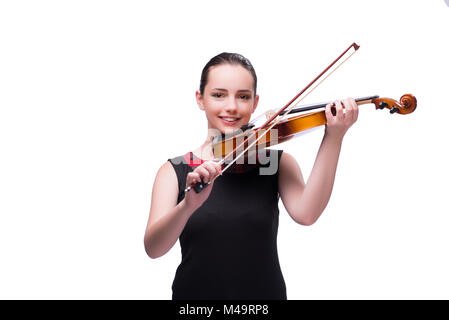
left=325, top=98, right=359, bottom=139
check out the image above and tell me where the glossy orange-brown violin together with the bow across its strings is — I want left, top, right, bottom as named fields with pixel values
left=184, top=43, right=417, bottom=193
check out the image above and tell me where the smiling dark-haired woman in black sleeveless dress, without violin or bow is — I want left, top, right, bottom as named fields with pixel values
left=144, top=53, right=358, bottom=299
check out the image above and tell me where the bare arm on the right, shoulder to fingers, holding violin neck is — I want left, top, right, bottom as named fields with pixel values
left=279, top=99, right=358, bottom=225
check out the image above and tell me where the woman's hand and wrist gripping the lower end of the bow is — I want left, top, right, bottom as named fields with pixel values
left=184, top=161, right=221, bottom=210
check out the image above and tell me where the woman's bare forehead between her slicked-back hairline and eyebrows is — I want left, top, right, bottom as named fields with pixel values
left=207, top=64, right=254, bottom=90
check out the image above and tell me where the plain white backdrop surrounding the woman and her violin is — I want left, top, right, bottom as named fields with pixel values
left=0, top=0, right=449, bottom=299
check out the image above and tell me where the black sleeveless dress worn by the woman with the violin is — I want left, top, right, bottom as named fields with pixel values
left=169, top=150, right=287, bottom=300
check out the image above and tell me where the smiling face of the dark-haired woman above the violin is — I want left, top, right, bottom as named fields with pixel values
left=196, top=64, right=259, bottom=133
